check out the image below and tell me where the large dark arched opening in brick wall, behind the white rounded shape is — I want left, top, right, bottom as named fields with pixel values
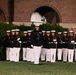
left=31, top=6, right=60, bottom=24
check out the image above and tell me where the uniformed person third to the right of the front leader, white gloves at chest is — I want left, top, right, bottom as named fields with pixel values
left=50, top=30, right=57, bottom=62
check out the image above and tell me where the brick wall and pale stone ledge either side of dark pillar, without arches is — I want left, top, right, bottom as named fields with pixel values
left=0, top=0, right=76, bottom=28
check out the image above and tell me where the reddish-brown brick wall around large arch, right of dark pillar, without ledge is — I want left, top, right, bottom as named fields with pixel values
left=14, top=0, right=76, bottom=23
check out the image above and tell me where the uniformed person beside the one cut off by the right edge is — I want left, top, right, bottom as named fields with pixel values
left=68, top=31, right=75, bottom=62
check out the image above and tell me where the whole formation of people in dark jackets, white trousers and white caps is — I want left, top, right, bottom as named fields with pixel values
left=5, top=25, right=76, bottom=64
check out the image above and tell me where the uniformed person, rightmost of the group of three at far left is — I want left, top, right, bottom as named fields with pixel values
left=14, top=29, right=21, bottom=62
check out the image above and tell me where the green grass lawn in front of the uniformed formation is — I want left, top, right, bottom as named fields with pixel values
left=0, top=61, right=76, bottom=75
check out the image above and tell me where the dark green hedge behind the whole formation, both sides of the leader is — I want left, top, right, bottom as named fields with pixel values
left=0, top=22, right=68, bottom=59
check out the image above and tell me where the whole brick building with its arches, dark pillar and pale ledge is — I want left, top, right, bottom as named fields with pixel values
left=0, top=0, right=76, bottom=30
